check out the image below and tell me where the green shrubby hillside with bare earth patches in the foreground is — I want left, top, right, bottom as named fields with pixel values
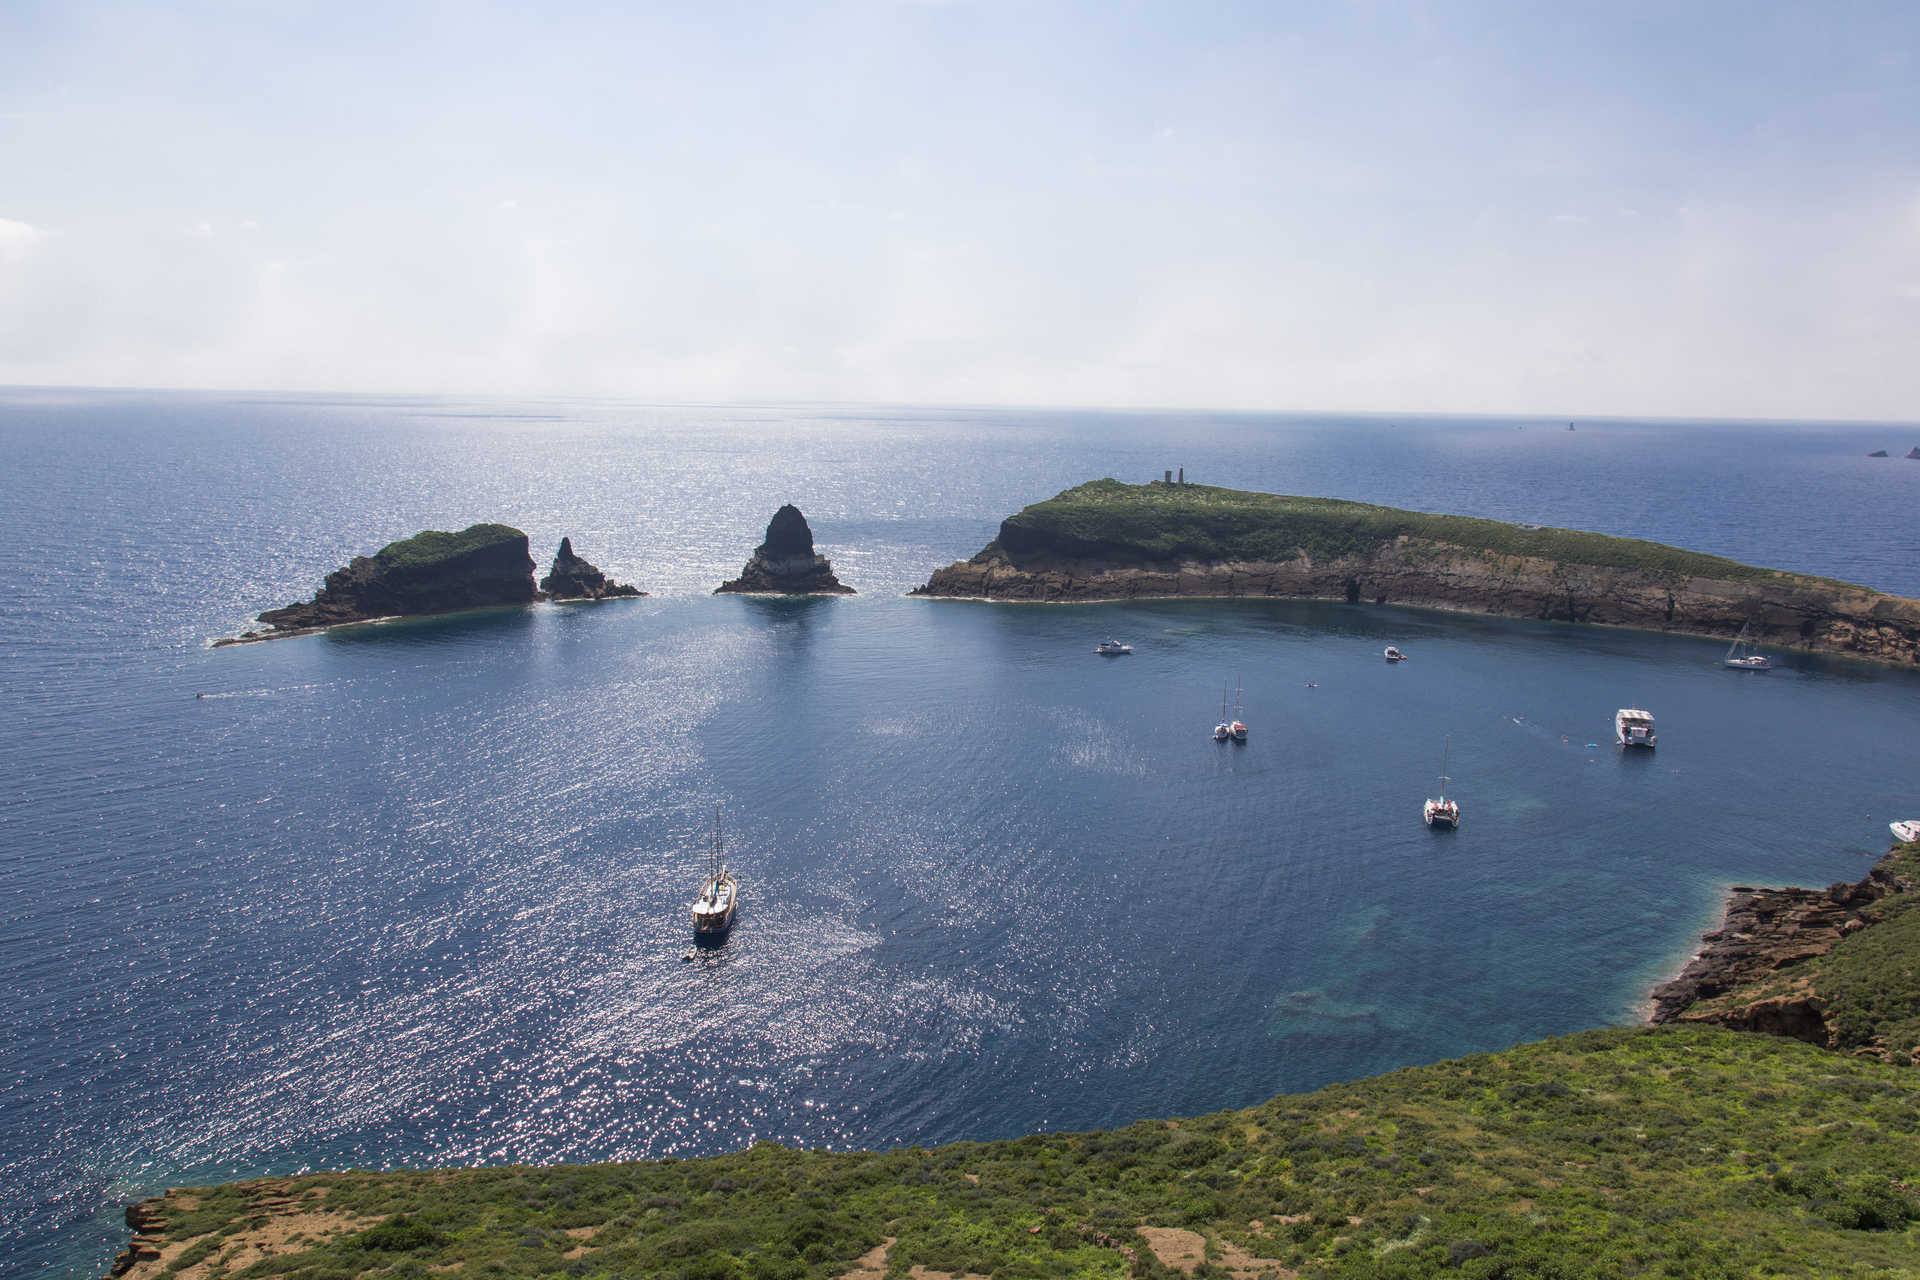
left=108, top=1027, right=1920, bottom=1280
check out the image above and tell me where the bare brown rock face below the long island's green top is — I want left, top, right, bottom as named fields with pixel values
left=912, top=522, right=1920, bottom=666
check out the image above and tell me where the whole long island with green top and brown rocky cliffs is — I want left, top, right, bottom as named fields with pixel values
left=912, top=480, right=1920, bottom=666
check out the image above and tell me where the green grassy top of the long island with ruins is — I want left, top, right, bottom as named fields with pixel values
left=975, top=480, right=1849, bottom=587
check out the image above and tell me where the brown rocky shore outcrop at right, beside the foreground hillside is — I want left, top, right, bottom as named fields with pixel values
left=1647, top=846, right=1920, bottom=1061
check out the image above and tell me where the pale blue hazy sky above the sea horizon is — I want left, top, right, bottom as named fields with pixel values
left=0, top=0, right=1920, bottom=420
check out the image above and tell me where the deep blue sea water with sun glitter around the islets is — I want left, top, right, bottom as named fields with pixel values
left=11, top=390, right=1920, bottom=1276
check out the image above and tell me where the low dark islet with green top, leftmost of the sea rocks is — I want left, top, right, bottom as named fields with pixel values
left=227, top=524, right=538, bottom=643
